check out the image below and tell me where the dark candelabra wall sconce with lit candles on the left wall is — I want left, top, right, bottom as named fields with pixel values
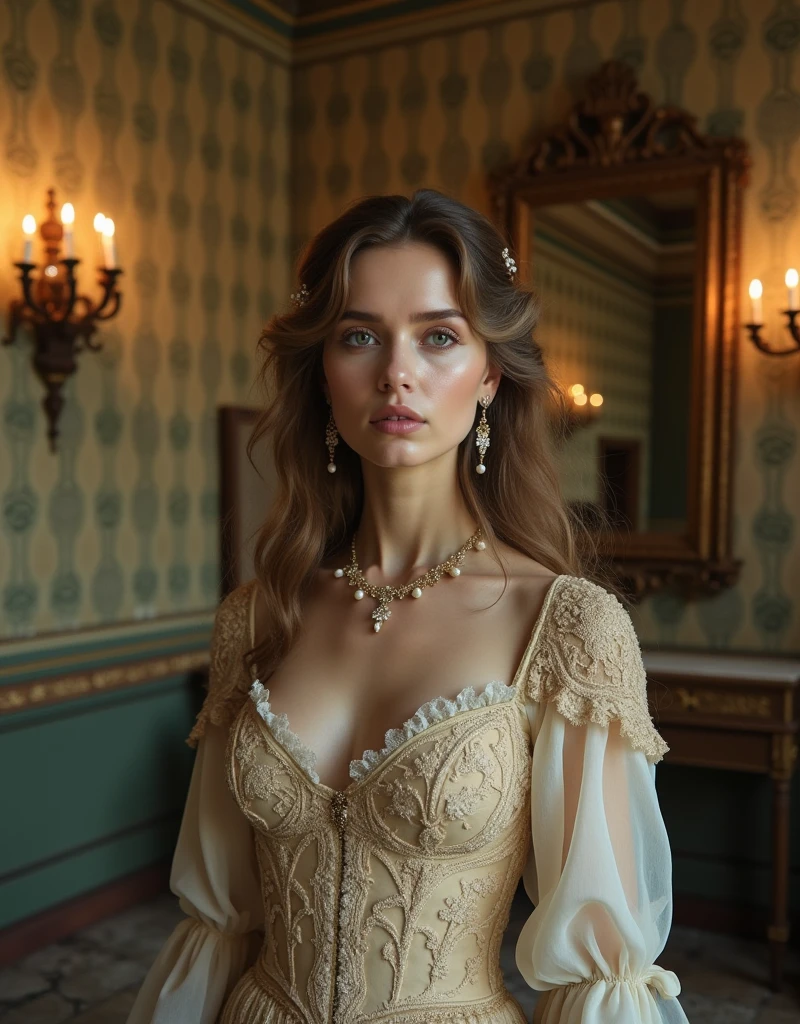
left=3, top=188, right=122, bottom=452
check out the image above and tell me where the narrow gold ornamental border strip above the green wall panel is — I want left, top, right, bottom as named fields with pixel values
left=0, top=650, right=209, bottom=716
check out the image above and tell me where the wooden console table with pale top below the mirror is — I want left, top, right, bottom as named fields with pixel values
left=642, top=651, right=800, bottom=991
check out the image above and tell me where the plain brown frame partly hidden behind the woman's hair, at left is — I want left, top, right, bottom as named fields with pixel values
left=218, top=406, right=277, bottom=600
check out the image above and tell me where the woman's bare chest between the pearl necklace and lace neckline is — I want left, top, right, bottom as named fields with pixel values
left=249, top=579, right=546, bottom=788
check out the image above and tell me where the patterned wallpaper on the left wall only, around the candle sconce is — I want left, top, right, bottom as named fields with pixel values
left=0, top=0, right=289, bottom=637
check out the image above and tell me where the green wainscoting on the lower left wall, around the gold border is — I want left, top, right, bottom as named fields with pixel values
left=0, top=614, right=210, bottom=928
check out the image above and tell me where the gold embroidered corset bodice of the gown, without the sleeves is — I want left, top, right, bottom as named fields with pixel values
left=221, top=684, right=531, bottom=1024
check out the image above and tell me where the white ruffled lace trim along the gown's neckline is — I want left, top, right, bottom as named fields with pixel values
left=250, top=679, right=517, bottom=785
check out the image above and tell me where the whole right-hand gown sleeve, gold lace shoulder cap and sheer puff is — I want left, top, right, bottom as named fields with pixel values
left=516, top=577, right=687, bottom=1024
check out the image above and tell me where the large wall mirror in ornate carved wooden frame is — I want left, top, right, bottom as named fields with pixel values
left=490, top=61, right=749, bottom=597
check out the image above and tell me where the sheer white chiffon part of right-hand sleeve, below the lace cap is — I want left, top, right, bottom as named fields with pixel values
left=516, top=703, right=686, bottom=1024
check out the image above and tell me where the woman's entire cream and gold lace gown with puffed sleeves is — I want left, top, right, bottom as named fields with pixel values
left=128, top=575, right=686, bottom=1024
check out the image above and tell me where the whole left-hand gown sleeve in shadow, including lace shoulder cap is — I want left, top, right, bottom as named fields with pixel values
left=128, top=588, right=263, bottom=1024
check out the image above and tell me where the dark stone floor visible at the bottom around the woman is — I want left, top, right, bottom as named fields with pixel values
left=0, top=894, right=800, bottom=1024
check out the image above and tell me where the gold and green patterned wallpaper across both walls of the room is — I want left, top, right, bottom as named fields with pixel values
left=0, top=0, right=800, bottom=651
